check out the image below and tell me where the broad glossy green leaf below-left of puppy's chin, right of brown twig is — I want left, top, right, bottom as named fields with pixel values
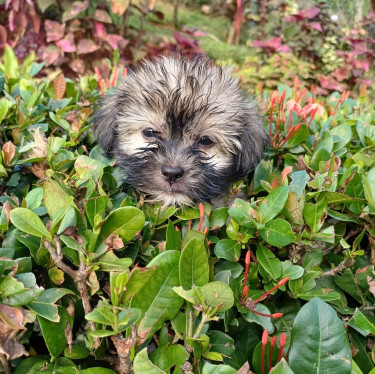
left=100, top=206, right=145, bottom=242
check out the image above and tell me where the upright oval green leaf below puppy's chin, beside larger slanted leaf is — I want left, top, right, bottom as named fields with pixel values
left=179, top=238, right=209, bottom=290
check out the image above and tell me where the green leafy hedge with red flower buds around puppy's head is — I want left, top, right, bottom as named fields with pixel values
left=0, top=48, right=375, bottom=374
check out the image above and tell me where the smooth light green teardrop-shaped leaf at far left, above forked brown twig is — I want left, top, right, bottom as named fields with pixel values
left=10, top=208, right=52, bottom=239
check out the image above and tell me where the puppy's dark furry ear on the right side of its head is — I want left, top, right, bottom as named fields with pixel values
left=236, top=114, right=268, bottom=178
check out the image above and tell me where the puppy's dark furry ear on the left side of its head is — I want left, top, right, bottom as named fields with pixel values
left=92, top=93, right=119, bottom=156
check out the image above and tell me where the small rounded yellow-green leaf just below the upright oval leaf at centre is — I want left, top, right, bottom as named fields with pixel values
left=200, top=282, right=234, bottom=312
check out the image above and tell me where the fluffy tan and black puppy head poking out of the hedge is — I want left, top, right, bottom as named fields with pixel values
left=94, top=57, right=266, bottom=205
